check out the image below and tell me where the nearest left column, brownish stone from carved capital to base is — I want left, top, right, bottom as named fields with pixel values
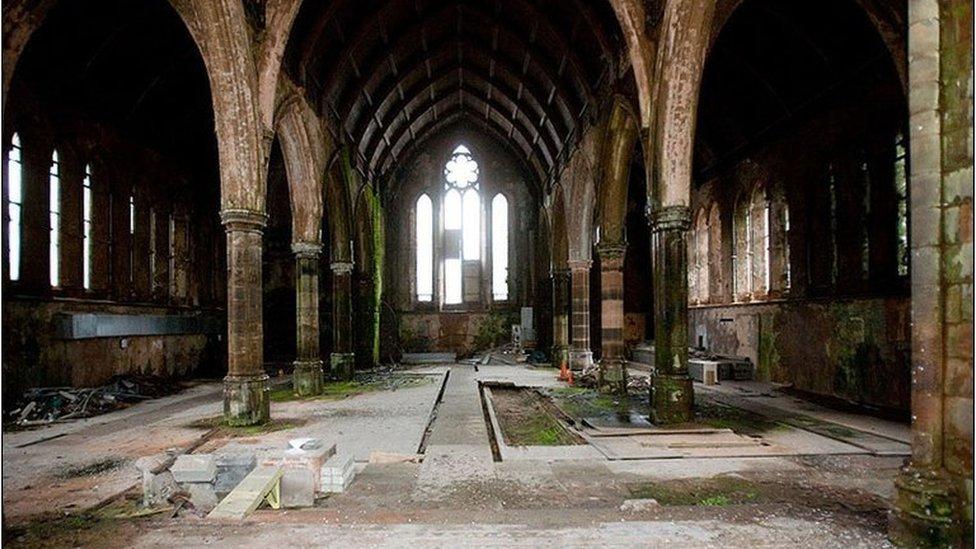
left=221, top=210, right=271, bottom=425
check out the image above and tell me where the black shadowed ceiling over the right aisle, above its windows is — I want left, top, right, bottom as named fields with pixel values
left=695, top=0, right=907, bottom=182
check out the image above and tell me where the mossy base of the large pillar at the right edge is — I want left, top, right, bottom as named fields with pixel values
left=888, top=465, right=972, bottom=547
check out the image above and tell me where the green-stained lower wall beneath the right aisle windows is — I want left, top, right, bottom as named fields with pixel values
left=688, top=298, right=911, bottom=415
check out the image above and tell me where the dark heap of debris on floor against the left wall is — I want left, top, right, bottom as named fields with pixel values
left=6, top=375, right=179, bottom=426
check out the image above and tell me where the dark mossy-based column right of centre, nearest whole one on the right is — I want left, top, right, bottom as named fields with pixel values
left=651, top=205, right=694, bottom=423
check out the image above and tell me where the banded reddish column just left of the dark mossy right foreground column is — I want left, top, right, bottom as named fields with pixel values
left=596, top=243, right=627, bottom=395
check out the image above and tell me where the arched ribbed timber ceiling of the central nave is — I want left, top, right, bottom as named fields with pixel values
left=285, top=0, right=621, bottom=191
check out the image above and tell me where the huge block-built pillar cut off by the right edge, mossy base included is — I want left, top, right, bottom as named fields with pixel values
left=888, top=0, right=973, bottom=547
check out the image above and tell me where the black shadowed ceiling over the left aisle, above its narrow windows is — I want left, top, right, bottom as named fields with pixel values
left=11, top=0, right=217, bottom=171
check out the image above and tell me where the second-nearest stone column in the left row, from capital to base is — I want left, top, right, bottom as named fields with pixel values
left=291, top=242, right=323, bottom=396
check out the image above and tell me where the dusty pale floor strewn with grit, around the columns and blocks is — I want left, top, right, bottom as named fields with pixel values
left=3, top=365, right=907, bottom=547
